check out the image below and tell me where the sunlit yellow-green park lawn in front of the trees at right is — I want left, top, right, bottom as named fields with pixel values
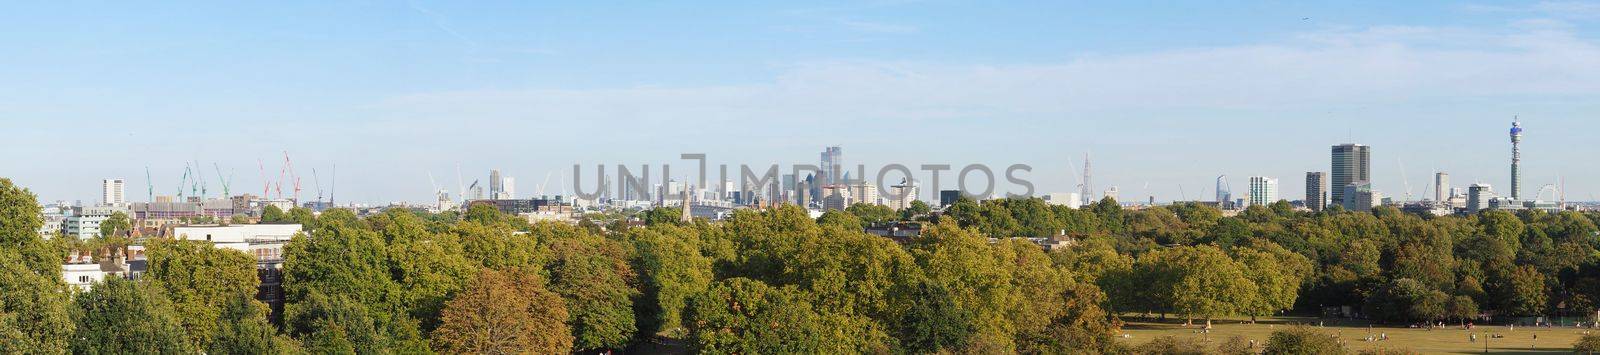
left=1122, top=317, right=1600, bottom=353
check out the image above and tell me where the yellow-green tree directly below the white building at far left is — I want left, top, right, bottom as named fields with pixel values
left=144, top=238, right=261, bottom=347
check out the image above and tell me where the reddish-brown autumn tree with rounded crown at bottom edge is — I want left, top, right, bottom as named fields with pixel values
left=434, top=270, right=573, bottom=353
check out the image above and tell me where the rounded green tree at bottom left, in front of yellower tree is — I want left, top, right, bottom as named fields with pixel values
left=72, top=278, right=195, bottom=353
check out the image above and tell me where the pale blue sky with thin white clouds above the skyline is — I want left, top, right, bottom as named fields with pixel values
left=0, top=0, right=1600, bottom=203
